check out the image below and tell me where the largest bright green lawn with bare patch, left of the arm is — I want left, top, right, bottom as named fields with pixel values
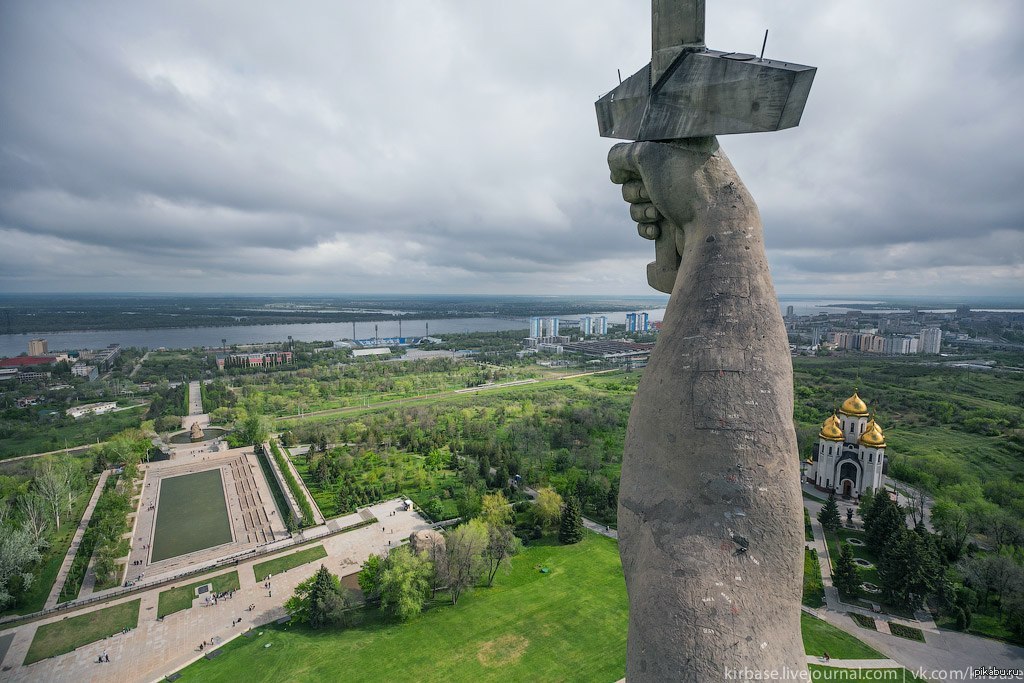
left=182, top=533, right=627, bottom=683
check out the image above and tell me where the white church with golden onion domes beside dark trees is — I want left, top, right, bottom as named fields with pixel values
left=806, top=391, right=886, bottom=497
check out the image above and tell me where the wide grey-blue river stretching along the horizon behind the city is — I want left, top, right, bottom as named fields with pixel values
left=0, top=299, right=983, bottom=356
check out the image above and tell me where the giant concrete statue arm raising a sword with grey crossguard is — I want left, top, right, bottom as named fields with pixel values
left=596, top=0, right=815, bottom=681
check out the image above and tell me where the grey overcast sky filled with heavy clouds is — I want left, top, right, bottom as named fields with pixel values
left=0, top=0, right=1024, bottom=296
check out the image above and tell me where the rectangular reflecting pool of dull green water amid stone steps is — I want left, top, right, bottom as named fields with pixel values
left=150, top=469, right=231, bottom=562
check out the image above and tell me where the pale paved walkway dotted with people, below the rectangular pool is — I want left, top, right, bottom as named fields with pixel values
left=0, top=499, right=430, bottom=683
